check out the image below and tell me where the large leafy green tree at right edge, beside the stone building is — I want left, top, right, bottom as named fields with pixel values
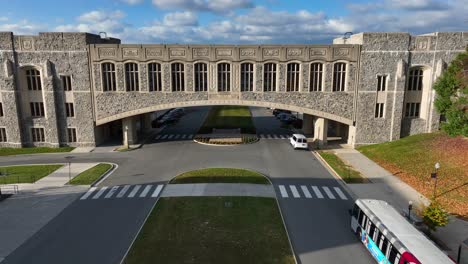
left=434, top=48, right=468, bottom=136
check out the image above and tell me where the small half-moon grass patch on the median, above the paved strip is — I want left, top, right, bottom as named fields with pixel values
left=170, top=168, right=270, bottom=184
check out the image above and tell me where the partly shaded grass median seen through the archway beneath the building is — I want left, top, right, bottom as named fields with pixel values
left=198, top=105, right=256, bottom=134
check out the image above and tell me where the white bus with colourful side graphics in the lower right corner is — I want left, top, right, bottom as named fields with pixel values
left=351, top=199, right=454, bottom=264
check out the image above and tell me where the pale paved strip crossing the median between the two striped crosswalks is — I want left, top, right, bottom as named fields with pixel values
left=161, top=183, right=276, bottom=198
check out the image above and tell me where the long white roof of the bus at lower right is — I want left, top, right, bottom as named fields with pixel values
left=356, top=199, right=453, bottom=264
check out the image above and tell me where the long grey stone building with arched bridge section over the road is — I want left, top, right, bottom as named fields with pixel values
left=0, top=32, right=468, bottom=147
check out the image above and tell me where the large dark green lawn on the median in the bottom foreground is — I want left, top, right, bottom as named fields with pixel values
left=124, top=197, right=295, bottom=264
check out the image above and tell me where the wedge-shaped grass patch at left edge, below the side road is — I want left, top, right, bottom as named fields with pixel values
left=0, top=164, right=63, bottom=184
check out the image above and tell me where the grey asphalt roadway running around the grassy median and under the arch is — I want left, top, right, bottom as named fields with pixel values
left=0, top=107, right=374, bottom=264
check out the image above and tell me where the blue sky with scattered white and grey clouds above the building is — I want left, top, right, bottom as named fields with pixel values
left=0, top=0, right=468, bottom=44
